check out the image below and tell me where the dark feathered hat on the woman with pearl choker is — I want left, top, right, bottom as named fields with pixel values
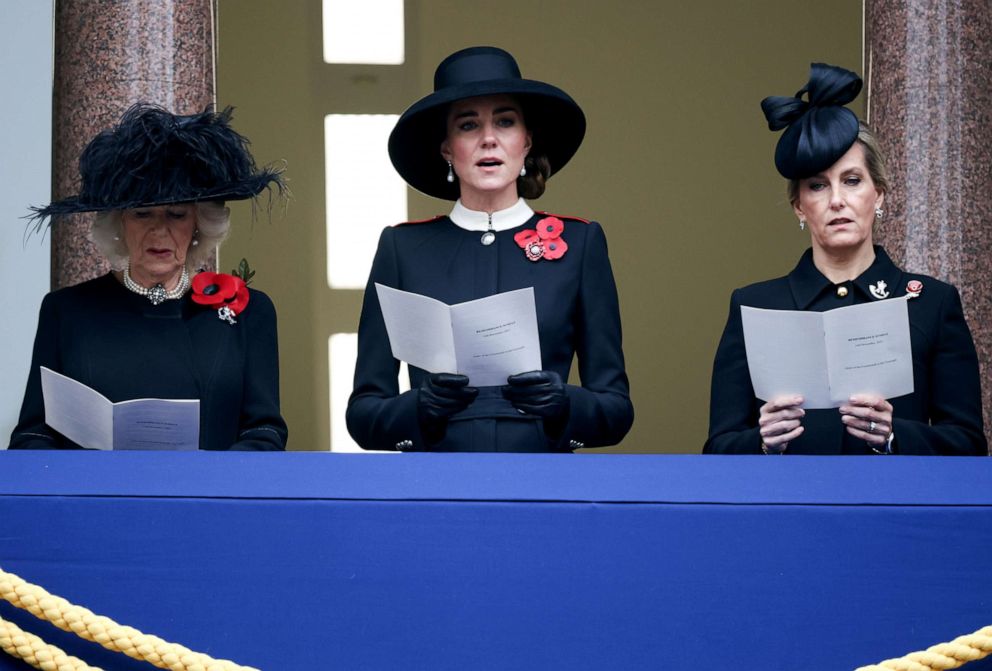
left=31, top=103, right=285, bottom=222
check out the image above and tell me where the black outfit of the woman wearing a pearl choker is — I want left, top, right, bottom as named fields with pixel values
left=10, top=274, right=287, bottom=450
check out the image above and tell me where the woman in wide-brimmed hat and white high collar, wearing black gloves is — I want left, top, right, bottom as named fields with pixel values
left=347, top=47, right=633, bottom=452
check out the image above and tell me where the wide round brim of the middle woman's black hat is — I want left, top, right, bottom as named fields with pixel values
left=389, top=79, right=586, bottom=200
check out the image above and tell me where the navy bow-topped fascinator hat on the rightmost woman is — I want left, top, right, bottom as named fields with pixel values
left=761, top=63, right=861, bottom=179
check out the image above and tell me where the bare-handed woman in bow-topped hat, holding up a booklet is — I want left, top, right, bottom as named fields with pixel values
left=704, top=63, right=987, bottom=455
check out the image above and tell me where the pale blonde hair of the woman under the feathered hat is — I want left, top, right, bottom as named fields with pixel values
left=90, top=200, right=231, bottom=273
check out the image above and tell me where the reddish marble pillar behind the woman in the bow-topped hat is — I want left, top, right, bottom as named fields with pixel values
left=865, top=0, right=992, bottom=452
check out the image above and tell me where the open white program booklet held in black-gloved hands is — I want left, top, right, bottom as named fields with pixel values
left=375, top=282, right=541, bottom=387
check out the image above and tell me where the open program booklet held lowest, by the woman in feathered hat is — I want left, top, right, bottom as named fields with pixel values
left=41, top=366, right=200, bottom=450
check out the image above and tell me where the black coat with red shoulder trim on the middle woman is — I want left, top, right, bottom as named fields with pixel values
left=347, top=213, right=633, bottom=452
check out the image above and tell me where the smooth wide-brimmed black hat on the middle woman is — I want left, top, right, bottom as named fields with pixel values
left=389, top=47, right=586, bottom=200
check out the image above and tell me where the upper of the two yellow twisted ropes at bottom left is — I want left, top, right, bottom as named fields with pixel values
left=0, top=568, right=259, bottom=671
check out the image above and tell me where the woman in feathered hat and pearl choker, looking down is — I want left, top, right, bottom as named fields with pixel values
left=10, top=104, right=287, bottom=450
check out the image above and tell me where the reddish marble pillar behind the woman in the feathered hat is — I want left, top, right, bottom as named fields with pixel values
left=51, top=0, right=216, bottom=289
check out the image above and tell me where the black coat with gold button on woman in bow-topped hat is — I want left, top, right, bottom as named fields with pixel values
left=703, top=246, right=988, bottom=455
